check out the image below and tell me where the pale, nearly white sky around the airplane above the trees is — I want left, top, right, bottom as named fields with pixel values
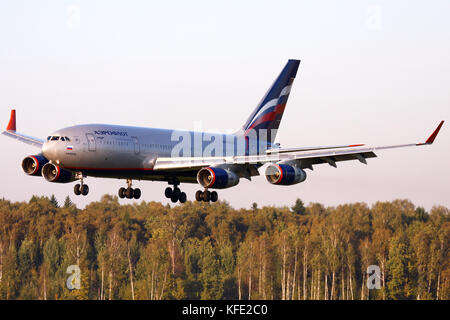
left=0, top=0, right=450, bottom=209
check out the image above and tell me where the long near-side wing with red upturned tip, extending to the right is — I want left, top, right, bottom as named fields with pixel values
left=153, top=121, right=444, bottom=171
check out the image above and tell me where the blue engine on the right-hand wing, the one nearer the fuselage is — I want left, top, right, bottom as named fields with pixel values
left=197, top=167, right=239, bottom=189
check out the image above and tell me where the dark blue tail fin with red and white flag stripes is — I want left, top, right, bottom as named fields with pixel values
left=243, top=60, right=300, bottom=142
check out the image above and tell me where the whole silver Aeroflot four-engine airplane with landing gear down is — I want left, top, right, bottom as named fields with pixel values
left=3, top=59, right=444, bottom=203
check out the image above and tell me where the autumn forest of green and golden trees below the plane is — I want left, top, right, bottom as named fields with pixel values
left=0, top=195, right=450, bottom=300
